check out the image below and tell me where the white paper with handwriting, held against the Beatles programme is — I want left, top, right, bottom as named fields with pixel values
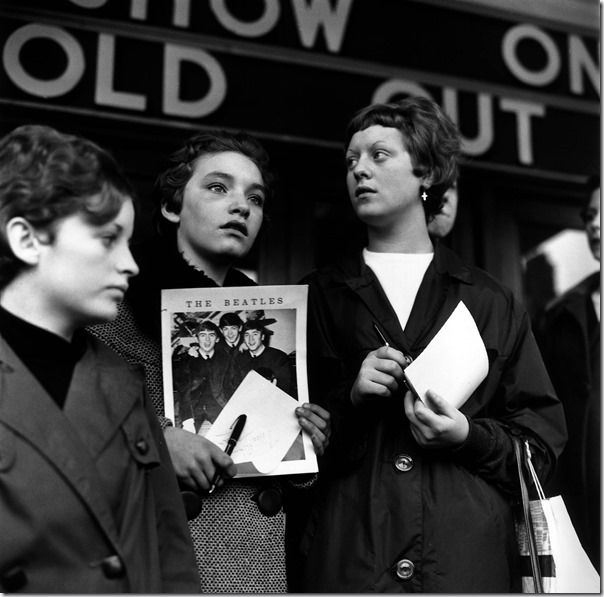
left=206, top=371, right=300, bottom=474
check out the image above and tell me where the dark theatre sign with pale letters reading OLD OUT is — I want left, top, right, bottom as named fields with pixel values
left=0, top=0, right=600, bottom=176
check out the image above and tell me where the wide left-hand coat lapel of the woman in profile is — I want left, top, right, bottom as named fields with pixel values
left=0, top=337, right=124, bottom=552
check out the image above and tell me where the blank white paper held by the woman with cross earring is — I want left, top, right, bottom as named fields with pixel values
left=405, top=301, right=489, bottom=408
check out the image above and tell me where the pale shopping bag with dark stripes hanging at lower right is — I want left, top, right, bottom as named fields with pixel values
left=514, top=439, right=601, bottom=593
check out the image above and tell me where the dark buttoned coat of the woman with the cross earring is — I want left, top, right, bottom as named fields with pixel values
left=303, top=246, right=566, bottom=593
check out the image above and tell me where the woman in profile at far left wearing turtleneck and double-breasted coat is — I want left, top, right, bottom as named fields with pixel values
left=0, top=125, right=199, bottom=595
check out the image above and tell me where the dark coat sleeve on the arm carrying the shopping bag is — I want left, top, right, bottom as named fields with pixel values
left=454, top=303, right=566, bottom=494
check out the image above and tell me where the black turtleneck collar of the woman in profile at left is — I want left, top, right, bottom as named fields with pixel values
left=0, top=307, right=86, bottom=408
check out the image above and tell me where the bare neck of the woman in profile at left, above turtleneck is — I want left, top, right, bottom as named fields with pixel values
left=0, top=273, right=78, bottom=342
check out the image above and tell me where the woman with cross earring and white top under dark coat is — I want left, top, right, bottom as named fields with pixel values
left=302, top=98, right=566, bottom=593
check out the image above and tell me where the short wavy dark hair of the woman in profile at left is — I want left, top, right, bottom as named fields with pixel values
left=0, top=125, right=135, bottom=287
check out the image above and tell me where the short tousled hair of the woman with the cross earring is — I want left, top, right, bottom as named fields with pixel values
left=345, top=96, right=461, bottom=217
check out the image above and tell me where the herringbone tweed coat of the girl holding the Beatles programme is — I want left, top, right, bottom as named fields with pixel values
left=90, top=303, right=287, bottom=594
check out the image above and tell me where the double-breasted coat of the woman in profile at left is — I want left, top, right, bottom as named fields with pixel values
left=0, top=330, right=199, bottom=593
